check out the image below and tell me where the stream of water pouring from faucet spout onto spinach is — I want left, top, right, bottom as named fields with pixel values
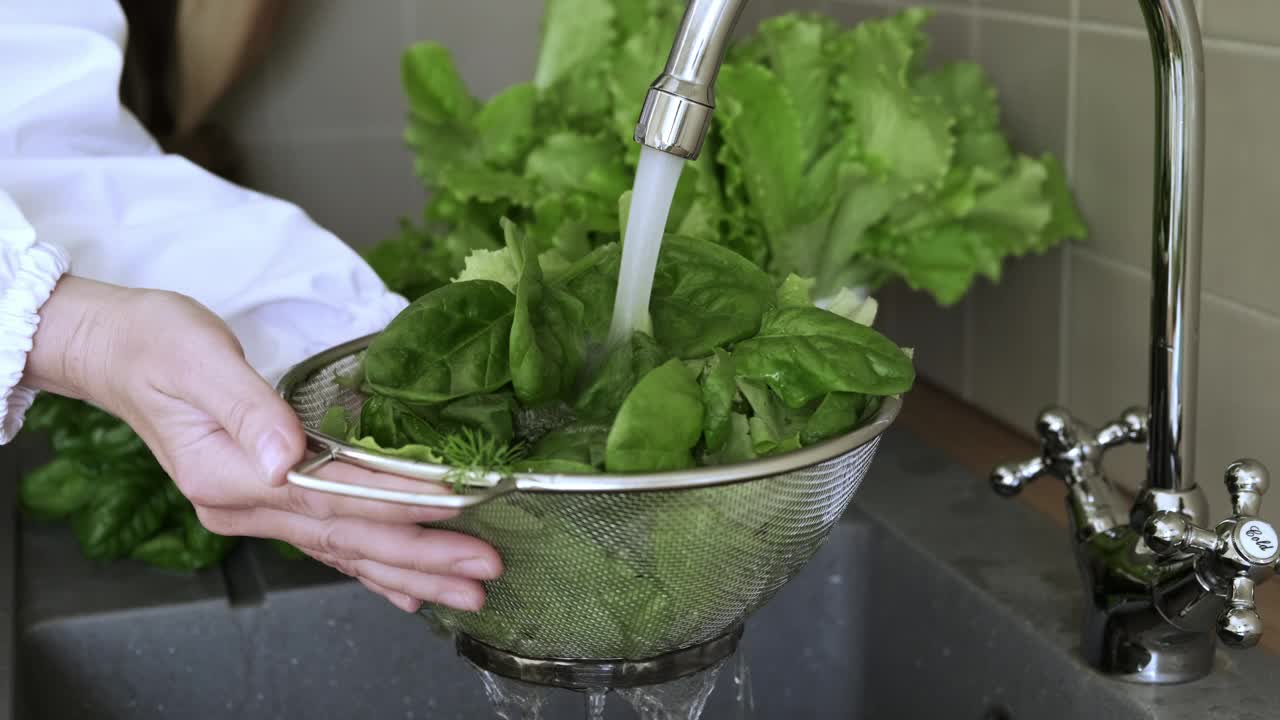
left=609, top=147, right=685, bottom=347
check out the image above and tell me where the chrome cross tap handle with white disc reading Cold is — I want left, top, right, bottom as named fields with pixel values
left=1143, top=460, right=1280, bottom=647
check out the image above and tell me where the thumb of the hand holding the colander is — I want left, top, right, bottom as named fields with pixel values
left=192, top=355, right=306, bottom=486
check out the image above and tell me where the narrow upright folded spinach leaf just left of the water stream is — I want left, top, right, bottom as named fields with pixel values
left=502, top=218, right=586, bottom=405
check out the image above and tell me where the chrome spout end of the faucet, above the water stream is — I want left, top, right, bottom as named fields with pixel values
left=635, top=0, right=746, bottom=160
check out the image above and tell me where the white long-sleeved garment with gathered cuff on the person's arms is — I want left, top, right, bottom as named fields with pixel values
left=0, top=0, right=406, bottom=443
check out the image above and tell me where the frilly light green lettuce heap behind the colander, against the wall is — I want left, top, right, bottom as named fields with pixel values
left=369, top=0, right=1085, bottom=303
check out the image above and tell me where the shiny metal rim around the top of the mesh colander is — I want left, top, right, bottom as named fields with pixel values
left=276, top=333, right=902, bottom=492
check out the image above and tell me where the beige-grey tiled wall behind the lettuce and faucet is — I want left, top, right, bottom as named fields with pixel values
left=223, top=0, right=1280, bottom=520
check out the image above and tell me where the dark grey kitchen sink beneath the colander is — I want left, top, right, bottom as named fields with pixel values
left=0, top=430, right=1280, bottom=720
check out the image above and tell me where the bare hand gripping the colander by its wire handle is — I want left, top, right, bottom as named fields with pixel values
left=23, top=277, right=502, bottom=612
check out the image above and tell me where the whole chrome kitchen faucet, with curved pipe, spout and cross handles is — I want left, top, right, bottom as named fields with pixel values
left=645, top=0, right=1280, bottom=683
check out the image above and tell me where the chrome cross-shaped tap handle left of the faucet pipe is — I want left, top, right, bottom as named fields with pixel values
left=991, top=407, right=1147, bottom=496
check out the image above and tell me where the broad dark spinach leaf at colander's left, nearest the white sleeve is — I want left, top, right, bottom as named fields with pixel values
left=365, top=281, right=516, bottom=404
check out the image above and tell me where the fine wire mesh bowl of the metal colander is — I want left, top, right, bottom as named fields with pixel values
left=285, top=345, right=879, bottom=660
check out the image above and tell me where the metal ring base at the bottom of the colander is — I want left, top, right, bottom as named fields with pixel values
left=457, top=625, right=742, bottom=691
